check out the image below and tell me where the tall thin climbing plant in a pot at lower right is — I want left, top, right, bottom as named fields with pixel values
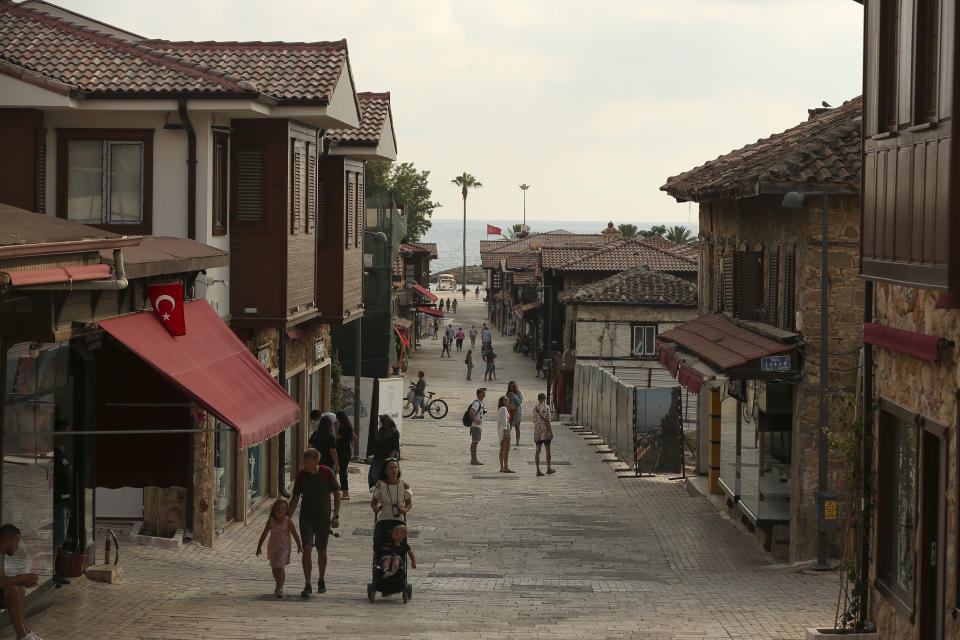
left=806, top=393, right=879, bottom=640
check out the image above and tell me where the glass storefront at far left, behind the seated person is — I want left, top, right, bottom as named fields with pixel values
left=0, top=342, right=75, bottom=584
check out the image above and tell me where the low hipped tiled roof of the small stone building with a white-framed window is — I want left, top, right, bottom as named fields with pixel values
left=560, top=265, right=697, bottom=307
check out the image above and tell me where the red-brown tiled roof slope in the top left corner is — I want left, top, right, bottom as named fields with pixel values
left=0, top=0, right=253, bottom=94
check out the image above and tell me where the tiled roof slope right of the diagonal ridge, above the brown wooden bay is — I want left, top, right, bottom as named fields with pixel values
left=141, top=40, right=349, bottom=104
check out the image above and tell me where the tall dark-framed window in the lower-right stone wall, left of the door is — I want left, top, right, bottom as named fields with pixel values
left=877, top=403, right=917, bottom=611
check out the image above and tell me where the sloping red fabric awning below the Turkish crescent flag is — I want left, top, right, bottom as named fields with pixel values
left=100, top=300, right=300, bottom=448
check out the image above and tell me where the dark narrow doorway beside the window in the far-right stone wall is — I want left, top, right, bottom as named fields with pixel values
left=918, top=422, right=947, bottom=640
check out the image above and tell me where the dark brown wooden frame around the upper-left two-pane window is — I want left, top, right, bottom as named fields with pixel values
left=56, top=129, right=154, bottom=235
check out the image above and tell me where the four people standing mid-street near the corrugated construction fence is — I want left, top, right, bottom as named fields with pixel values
left=468, top=380, right=556, bottom=476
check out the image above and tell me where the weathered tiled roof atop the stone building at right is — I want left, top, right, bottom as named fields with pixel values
left=660, top=97, right=863, bottom=202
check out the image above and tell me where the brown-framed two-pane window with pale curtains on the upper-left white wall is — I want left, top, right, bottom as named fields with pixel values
left=57, top=129, right=153, bottom=234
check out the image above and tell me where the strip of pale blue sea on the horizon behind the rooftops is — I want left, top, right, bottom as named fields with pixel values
left=420, top=218, right=699, bottom=273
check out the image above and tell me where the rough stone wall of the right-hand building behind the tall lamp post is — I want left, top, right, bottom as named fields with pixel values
left=698, top=195, right=863, bottom=561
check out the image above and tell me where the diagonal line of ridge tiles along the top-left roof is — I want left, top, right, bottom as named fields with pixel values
left=0, top=0, right=256, bottom=93
